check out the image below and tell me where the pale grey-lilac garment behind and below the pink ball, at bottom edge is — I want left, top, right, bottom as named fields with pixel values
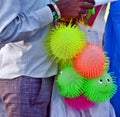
left=50, top=84, right=116, bottom=117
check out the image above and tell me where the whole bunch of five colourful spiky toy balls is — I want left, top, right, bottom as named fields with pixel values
left=45, top=24, right=117, bottom=109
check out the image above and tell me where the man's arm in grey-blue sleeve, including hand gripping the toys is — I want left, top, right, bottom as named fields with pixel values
left=0, top=0, right=94, bottom=44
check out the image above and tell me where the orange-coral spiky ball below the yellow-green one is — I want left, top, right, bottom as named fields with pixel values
left=73, top=43, right=106, bottom=78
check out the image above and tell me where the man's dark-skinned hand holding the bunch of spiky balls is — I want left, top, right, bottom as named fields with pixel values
left=56, top=0, right=95, bottom=19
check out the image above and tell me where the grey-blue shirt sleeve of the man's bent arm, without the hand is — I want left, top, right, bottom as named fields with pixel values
left=0, top=0, right=53, bottom=44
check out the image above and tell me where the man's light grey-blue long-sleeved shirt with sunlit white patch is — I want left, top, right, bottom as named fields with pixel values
left=0, top=0, right=57, bottom=79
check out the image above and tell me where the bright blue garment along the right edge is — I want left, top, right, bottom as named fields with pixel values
left=104, top=0, right=120, bottom=117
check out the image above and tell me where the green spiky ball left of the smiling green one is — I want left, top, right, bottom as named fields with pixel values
left=56, top=66, right=84, bottom=98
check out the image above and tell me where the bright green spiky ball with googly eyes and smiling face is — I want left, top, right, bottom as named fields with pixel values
left=84, top=72, right=117, bottom=102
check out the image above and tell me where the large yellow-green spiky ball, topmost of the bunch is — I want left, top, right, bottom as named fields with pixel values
left=46, top=24, right=87, bottom=61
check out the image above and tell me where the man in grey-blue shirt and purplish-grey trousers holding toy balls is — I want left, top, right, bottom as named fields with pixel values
left=0, top=0, right=94, bottom=117
